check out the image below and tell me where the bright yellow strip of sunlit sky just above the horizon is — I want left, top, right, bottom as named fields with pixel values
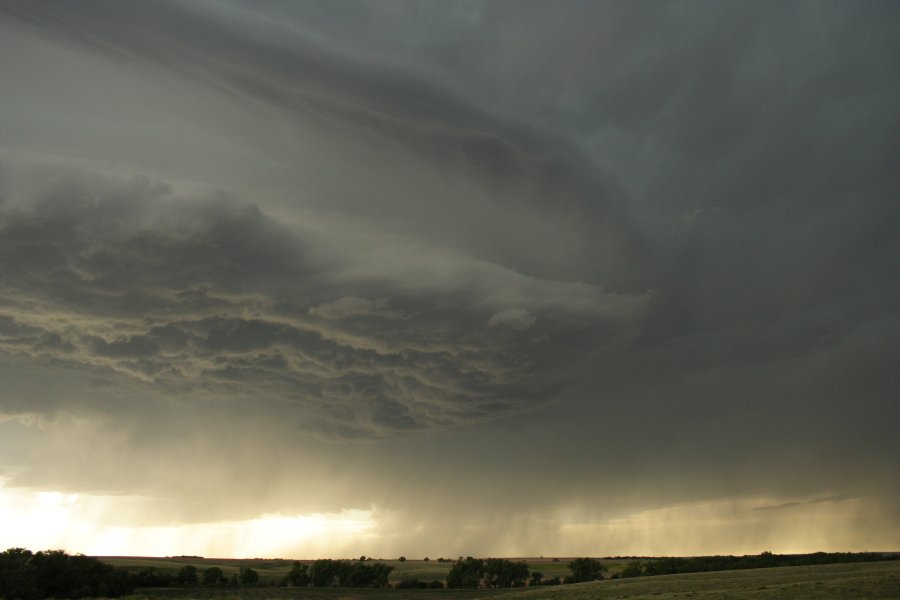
left=0, top=480, right=896, bottom=560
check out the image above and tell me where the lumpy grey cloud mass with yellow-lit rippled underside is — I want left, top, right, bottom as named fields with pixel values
left=0, top=168, right=639, bottom=437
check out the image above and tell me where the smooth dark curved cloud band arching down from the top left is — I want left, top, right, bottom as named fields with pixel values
left=0, top=2, right=652, bottom=291
